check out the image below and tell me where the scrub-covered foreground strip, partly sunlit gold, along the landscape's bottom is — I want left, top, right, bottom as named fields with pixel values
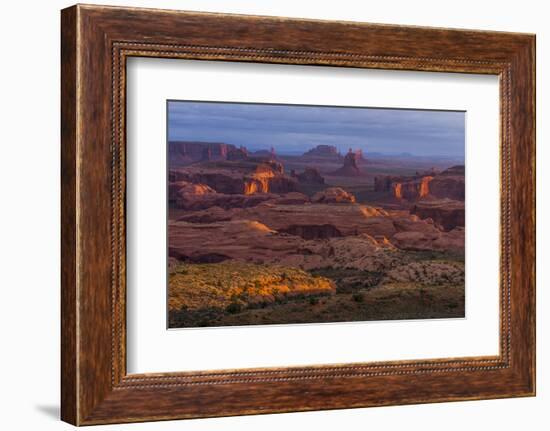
left=169, top=252, right=464, bottom=327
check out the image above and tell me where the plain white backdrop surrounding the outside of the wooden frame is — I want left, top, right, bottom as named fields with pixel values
left=0, top=0, right=550, bottom=431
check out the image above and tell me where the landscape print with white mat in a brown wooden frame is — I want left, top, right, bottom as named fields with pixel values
left=61, top=5, right=535, bottom=425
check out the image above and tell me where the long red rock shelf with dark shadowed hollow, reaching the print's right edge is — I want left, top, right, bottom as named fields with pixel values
left=174, top=200, right=464, bottom=255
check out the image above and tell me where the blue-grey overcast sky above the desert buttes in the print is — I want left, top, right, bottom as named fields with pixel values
left=168, top=101, right=465, bottom=158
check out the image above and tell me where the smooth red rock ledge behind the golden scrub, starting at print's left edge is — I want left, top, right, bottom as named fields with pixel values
left=168, top=220, right=398, bottom=271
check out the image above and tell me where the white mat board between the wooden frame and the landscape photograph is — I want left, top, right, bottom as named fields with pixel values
left=127, top=58, right=500, bottom=373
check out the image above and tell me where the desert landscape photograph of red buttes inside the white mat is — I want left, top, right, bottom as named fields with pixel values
left=167, top=100, right=465, bottom=328
